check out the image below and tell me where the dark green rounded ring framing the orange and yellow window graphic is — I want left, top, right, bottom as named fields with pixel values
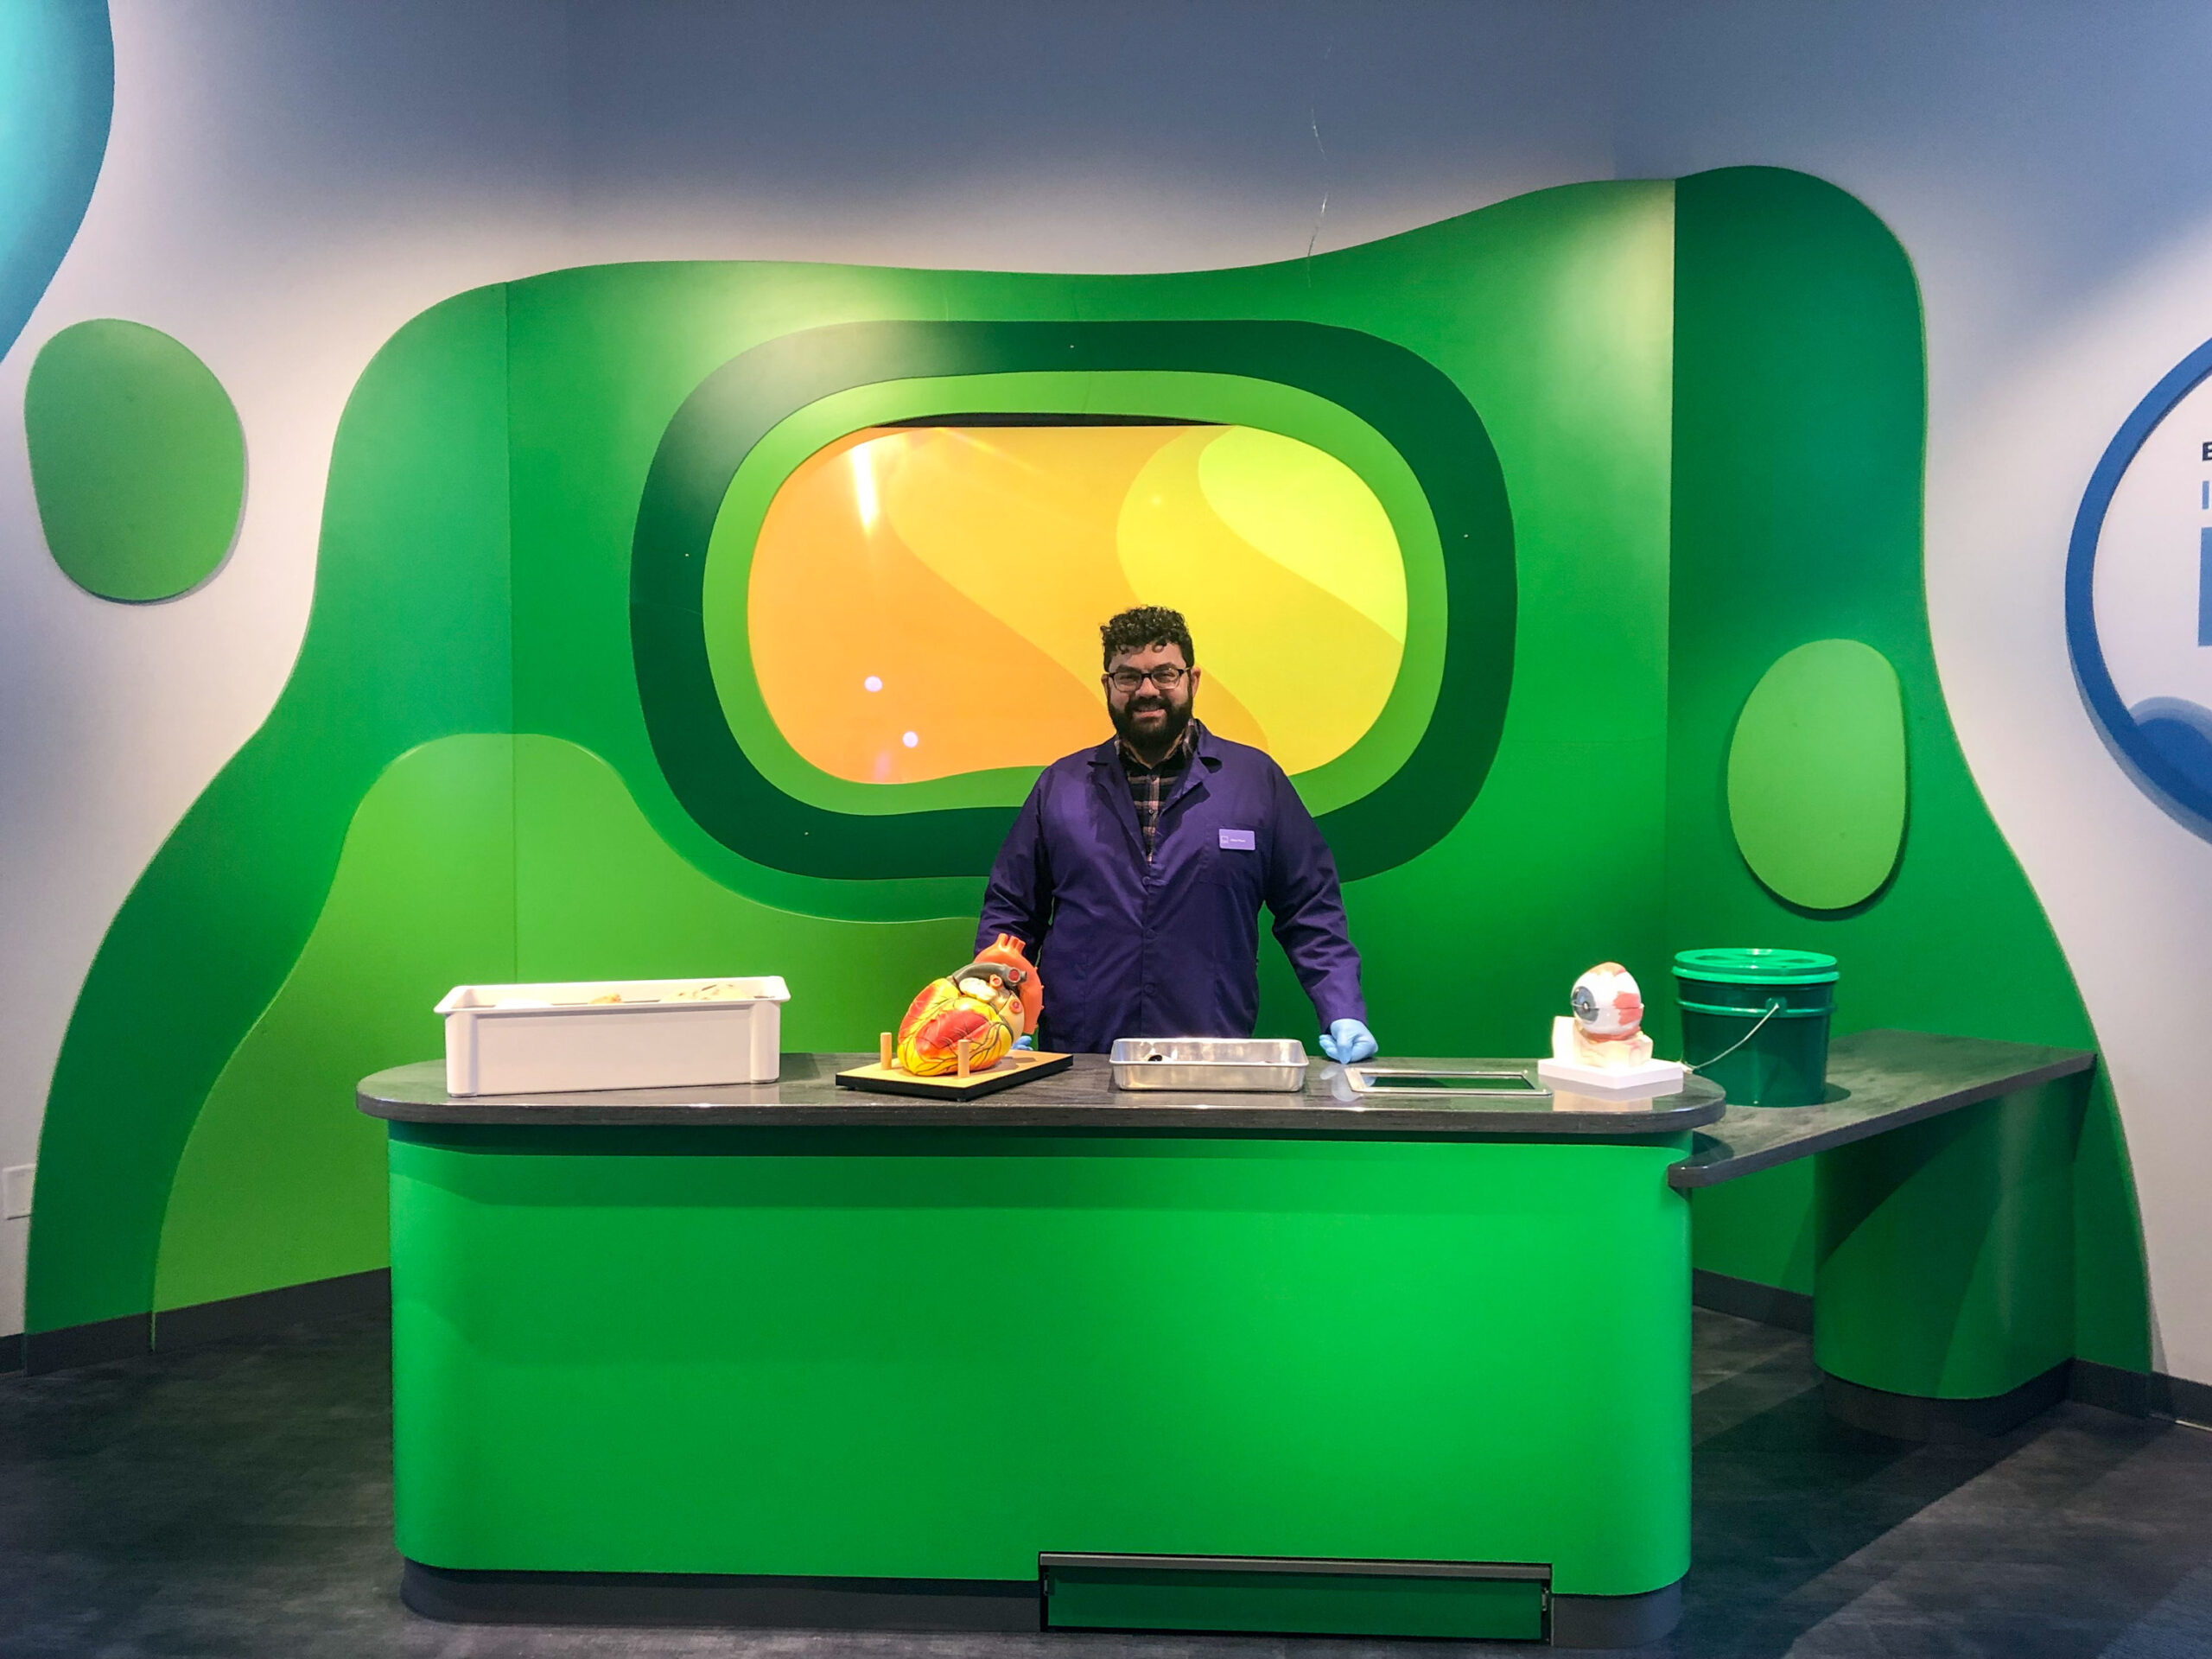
left=631, top=321, right=1516, bottom=880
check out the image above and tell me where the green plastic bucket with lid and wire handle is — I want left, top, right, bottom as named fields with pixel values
left=1675, top=949, right=1838, bottom=1106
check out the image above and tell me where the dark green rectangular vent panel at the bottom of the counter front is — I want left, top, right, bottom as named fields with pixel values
left=1038, top=1553, right=1551, bottom=1642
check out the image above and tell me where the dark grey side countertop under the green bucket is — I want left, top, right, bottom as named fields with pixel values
left=1668, top=1031, right=2097, bottom=1190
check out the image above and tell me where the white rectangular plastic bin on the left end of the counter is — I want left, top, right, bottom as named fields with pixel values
left=438, top=973, right=791, bottom=1095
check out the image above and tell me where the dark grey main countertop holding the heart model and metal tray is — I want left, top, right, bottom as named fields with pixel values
left=359, top=1055, right=1721, bottom=1139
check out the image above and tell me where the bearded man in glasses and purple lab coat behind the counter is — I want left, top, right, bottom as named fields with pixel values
left=976, top=606, right=1376, bottom=1062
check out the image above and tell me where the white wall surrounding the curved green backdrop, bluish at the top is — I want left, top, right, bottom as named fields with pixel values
left=0, top=0, right=2212, bottom=1380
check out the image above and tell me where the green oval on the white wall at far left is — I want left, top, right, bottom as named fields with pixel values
left=22, top=319, right=245, bottom=601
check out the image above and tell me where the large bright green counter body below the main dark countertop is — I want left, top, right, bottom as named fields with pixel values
left=363, top=1055, right=1719, bottom=1642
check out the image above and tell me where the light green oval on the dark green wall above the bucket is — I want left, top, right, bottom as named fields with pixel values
left=1727, top=639, right=1907, bottom=909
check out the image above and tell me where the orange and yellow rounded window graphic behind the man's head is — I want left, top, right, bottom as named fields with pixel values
left=747, top=425, right=1407, bottom=783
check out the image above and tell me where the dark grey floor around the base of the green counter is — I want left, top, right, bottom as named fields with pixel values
left=0, top=1312, right=2212, bottom=1659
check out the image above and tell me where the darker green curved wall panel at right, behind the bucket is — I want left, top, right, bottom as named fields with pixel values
left=1672, top=168, right=2150, bottom=1371
